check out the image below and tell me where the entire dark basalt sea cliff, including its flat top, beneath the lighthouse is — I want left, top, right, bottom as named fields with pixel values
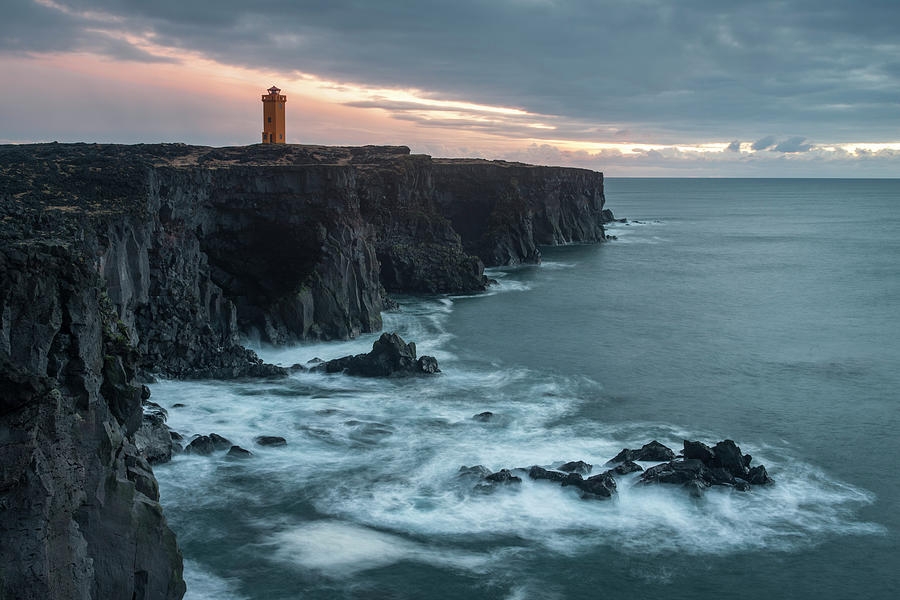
left=0, top=144, right=604, bottom=599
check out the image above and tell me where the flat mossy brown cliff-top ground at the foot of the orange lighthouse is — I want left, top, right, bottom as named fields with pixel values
left=0, top=142, right=604, bottom=242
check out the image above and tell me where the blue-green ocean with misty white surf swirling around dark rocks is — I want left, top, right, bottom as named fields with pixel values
left=152, top=179, right=900, bottom=600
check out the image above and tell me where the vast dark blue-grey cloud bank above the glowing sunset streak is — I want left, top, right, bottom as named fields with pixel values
left=7, top=0, right=900, bottom=142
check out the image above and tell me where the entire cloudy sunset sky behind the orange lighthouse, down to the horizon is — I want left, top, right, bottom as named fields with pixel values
left=0, top=0, right=900, bottom=177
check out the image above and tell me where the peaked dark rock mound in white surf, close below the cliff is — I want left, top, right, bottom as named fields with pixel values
left=314, top=333, right=440, bottom=377
